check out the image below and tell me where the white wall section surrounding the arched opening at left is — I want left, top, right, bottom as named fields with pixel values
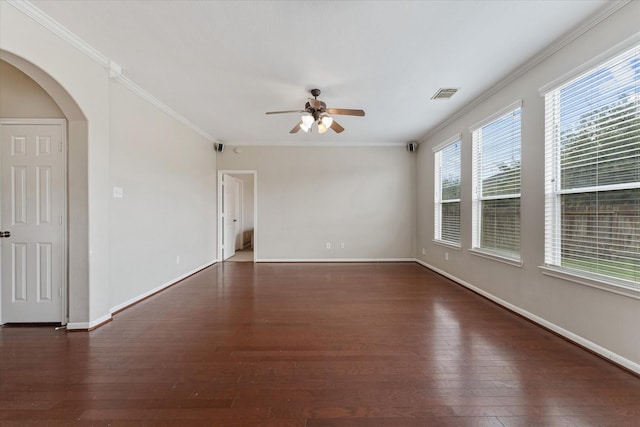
left=0, top=1, right=109, bottom=327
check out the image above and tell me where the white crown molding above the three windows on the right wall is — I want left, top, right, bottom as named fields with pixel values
left=419, top=0, right=633, bottom=142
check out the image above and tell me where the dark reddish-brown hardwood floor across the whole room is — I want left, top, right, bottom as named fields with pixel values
left=0, top=263, right=640, bottom=427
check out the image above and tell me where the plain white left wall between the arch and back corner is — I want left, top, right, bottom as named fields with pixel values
left=109, top=81, right=216, bottom=308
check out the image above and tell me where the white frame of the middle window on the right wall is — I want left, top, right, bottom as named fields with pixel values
left=469, top=99, right=523, bottom=267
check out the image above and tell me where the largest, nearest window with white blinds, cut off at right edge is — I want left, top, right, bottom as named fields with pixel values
left=545, top=45, right=640, bottom=287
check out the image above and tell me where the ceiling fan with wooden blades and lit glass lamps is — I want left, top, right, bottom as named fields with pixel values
left=267, top=89, right=364, bottom=133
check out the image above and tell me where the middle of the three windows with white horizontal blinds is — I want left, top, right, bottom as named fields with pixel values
left=471, top=102, right=521, bottom=261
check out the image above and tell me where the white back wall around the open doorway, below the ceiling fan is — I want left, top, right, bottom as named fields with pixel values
left=218, top=146, right=415, bottom=260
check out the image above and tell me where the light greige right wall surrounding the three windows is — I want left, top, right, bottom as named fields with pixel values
left=417, top=2, right=640, bottom=370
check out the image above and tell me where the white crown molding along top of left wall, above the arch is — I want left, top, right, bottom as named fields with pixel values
left=6, top=0, right=216, bottom=142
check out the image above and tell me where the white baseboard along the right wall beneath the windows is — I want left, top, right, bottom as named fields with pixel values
left=414, top=259, right=640, bottom=374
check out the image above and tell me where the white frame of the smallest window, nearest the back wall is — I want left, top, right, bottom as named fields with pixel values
left=433, top=134, right=462, bottom=249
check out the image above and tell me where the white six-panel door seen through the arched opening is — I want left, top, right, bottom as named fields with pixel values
left=0, top=124, right=65, bottom=323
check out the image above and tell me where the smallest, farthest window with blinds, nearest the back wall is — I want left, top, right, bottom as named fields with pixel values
left=434, top=135, right=462, bottom=246
